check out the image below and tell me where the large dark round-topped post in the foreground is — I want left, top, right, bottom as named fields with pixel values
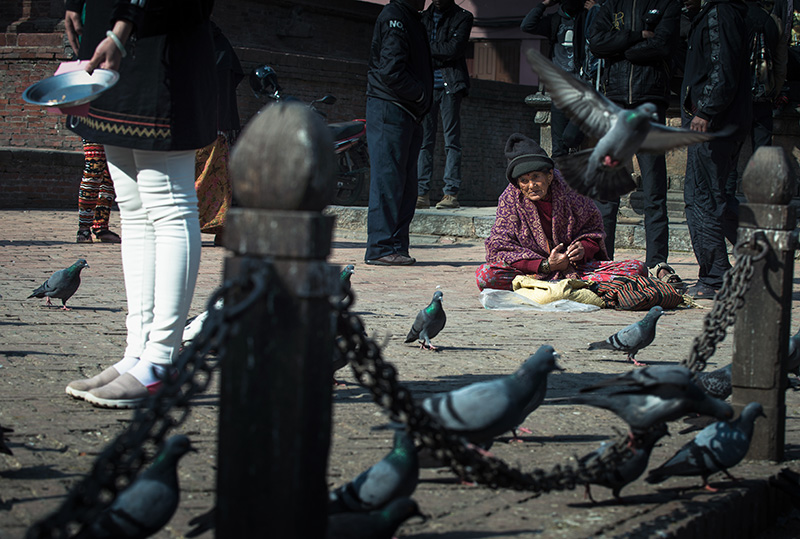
left=216, top=103, right=336, bottom=537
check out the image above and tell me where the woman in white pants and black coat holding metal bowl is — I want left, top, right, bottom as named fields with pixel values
left=66, top=0, right=217, bottom=408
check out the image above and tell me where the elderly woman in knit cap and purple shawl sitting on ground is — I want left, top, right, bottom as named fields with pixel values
left=476, top=133, right=648, bottom=290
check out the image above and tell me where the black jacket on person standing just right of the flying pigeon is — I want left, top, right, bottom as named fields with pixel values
left=681, top=0, right=752, bottom=123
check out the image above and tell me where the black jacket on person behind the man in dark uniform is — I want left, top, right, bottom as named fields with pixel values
left=422, top=4, right=473, bottom=95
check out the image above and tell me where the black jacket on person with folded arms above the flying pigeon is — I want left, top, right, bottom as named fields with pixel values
left=588, top=0, right=681, bottom=105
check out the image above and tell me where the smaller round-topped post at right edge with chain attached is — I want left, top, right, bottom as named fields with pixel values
left=732, top=146, right=796, bottom=461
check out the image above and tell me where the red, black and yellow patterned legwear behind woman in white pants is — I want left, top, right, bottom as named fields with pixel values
left=78, top=140, right=114, bottom=231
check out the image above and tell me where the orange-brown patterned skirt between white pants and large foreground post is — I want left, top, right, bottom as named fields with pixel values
left=194, top=135, right=233, bottom=234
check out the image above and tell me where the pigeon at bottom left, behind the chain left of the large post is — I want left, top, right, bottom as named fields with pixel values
left=76, top=434, right=193, bottom=539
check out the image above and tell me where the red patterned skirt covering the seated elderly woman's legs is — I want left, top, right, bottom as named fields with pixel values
left=475, top=260, right=648, bottom=290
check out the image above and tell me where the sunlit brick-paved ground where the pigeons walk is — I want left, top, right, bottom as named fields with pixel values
left=0, top=211, right=800, bottom=539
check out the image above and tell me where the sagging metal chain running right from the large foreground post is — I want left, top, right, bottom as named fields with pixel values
left=336, top=293, right=633, bottom=495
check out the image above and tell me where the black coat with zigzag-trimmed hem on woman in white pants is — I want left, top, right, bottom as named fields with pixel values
left=67, top=0, right=217, bottom=151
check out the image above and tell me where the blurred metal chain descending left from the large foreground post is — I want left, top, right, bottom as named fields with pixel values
left=26, top=259, right=273, bottom=539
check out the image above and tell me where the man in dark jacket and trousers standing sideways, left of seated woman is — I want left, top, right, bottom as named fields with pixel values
left=364, top=0, right=433, bottom=266
